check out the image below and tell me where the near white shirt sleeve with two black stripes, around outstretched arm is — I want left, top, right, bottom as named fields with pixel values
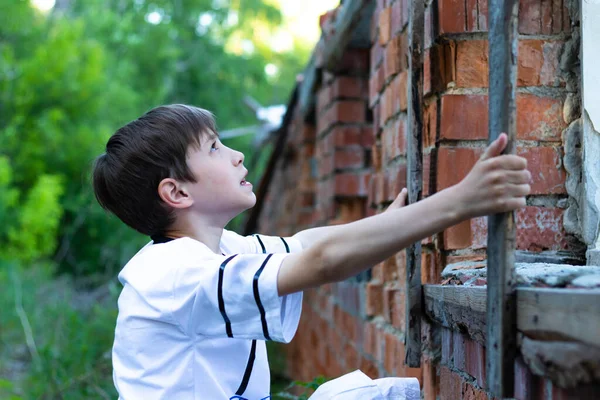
left=173, top=253, right=302, bottom=343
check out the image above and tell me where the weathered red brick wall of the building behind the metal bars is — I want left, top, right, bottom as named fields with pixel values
left=259, top=0, right=578, bottom=399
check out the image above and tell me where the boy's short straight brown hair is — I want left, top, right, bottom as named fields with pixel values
left=92, top=104, right=217, bottom=236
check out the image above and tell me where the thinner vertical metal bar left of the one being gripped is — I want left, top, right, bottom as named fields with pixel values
left=404, top=0, right=425, bottom=367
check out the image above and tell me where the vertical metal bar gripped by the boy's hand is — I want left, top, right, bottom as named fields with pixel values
left=486, top=0, right=519, bottom=398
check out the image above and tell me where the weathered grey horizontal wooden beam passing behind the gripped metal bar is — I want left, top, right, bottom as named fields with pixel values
left=423, top=285, right=600, bottom=349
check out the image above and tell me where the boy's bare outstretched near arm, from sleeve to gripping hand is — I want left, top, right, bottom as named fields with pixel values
left=277, top=134, right=531, bottom=296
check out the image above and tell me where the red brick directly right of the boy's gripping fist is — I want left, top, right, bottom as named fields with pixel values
left=517, top=147, right=566, bottom=194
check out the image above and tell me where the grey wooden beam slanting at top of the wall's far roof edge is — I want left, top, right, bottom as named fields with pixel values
left=323, top=0, right=376, bottom=71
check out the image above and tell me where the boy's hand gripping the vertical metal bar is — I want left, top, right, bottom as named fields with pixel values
left=455, top=133, right=531, bottom=218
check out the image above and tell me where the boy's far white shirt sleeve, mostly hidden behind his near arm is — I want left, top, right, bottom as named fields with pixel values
left=221, top=230, right=302, bottom=254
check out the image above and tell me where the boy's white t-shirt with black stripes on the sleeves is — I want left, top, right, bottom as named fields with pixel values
left=112, top=231, right=302, bottom=400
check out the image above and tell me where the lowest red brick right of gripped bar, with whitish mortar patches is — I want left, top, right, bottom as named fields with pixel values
left=516, top=206, right=569, bottom=251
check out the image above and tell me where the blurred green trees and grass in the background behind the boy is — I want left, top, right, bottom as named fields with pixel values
left=0, top=0, right=309, bottom=399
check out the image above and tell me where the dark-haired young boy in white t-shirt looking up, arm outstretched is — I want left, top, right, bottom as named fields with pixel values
left=93, top=105, right=531, bottom=400
